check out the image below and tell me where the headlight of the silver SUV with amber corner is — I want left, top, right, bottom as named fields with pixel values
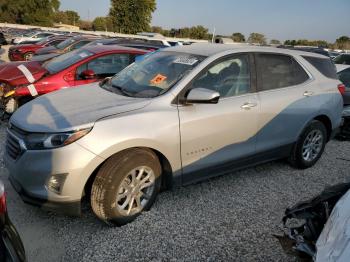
left=25, top=128, right=92, bottom=150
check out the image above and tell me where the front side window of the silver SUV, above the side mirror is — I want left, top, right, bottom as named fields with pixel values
left=190, top=55, right=251, bottom=97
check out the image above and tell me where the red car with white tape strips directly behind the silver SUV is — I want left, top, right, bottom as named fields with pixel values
left=0, top=45, right=147, bottom=114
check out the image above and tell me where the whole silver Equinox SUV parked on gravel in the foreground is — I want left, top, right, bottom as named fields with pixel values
left=5, top=44, right=343, bottom=225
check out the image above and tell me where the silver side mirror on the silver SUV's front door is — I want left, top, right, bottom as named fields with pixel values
left=185, top=88, right=220, bottom=104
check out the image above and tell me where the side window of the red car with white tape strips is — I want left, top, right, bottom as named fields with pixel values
left=76, top=54, right=134, bottom=80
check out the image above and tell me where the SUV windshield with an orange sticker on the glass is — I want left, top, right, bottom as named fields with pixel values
left=106, top=51, right=205, bottom=98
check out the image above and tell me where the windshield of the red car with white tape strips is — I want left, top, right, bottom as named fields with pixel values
left=43, top=49, right=94, bottom=74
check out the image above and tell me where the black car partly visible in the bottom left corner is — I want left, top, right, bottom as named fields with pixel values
left=0, top=180, right=26, bottom=262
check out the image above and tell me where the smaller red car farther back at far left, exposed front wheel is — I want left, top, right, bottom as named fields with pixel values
left=8, top=36, right=68, bottom=61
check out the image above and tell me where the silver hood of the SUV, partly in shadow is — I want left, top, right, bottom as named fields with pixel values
left=10, top=83, right=150, bottom=133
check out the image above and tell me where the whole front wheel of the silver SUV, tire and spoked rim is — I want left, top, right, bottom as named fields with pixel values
left=91, top=149, right=161, bottom=226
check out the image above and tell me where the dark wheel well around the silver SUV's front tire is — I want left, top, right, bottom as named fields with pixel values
left=83, top=147, right=173, bottom=198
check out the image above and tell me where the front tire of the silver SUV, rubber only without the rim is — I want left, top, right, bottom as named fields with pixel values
left=91, top=148, right=161, bottom=226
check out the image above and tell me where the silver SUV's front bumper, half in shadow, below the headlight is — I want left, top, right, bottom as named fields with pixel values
left=4, top=137, right=103, bottom=215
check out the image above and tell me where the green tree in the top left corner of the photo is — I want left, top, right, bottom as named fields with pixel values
left=0, top=0, right=60, bottom=26
